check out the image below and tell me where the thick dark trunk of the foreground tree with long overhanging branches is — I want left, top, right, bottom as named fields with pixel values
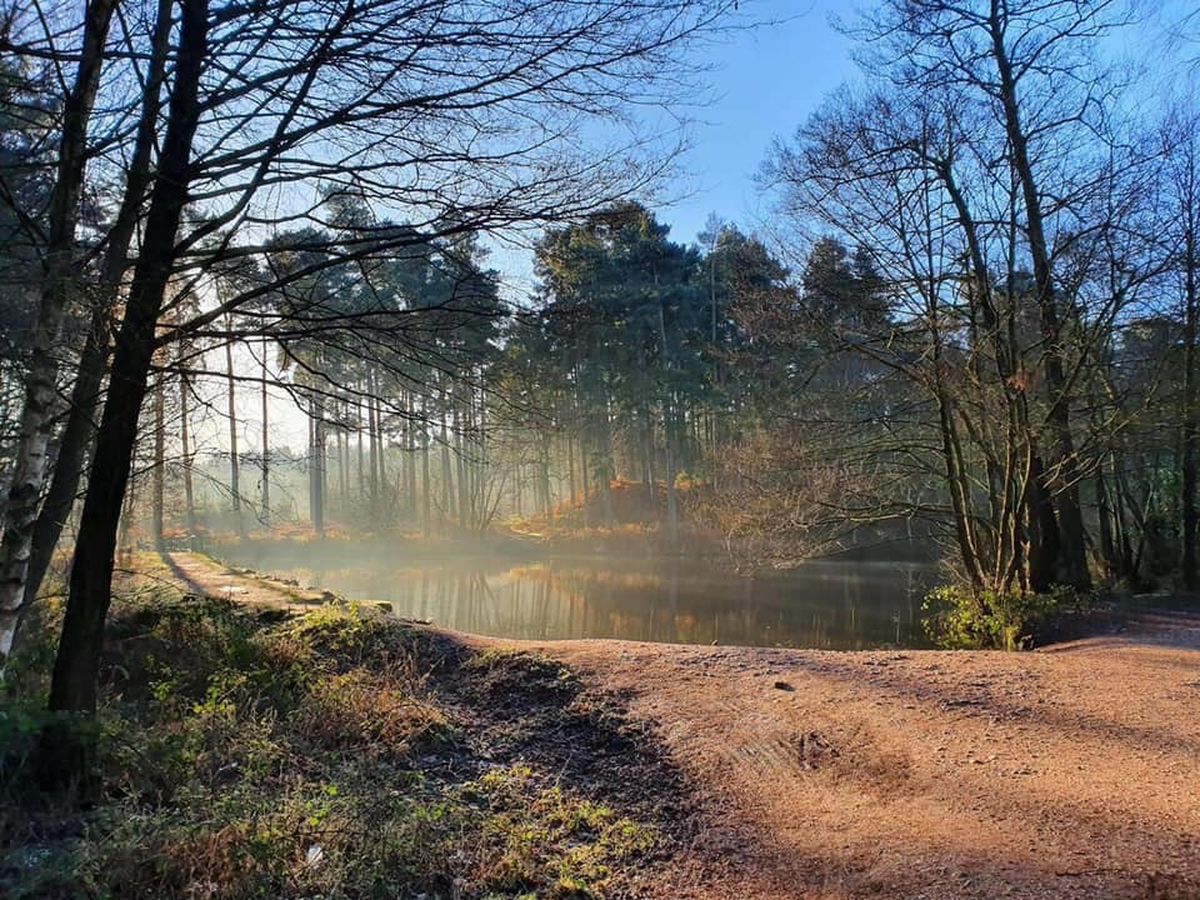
left=41, top=0, right=208, bottom=784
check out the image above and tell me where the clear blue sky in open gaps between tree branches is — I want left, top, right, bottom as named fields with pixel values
left=491, top=0, right=1200, bottom=301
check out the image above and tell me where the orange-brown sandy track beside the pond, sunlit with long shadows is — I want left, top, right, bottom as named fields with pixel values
left=162, top=554, right=1200, bottom=900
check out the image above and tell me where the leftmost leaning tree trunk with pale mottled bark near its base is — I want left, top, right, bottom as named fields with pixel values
left=0, top=0, right=116, bottom=674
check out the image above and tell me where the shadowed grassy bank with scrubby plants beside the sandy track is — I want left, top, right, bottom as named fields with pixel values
left=0, top=589, right=689, bottom=898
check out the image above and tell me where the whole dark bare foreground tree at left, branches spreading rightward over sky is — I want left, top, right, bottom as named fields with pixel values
left=21, top=0, right=733, bottom=787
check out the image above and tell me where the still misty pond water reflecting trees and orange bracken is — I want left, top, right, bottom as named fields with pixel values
left=211, top=547, right=930, bottom=649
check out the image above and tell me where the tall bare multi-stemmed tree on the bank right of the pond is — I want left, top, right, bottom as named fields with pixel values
left=768, top=0, right=1146, bottom=590
